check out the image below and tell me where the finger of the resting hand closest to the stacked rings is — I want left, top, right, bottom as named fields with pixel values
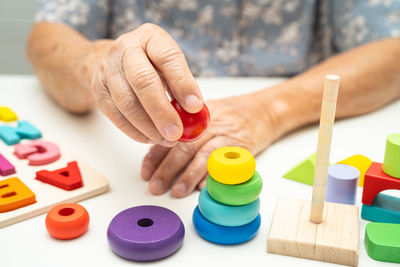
left=172, top=137, right=225, bottom=197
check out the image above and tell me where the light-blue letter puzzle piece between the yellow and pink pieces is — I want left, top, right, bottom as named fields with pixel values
left=0, top=121, right=42, bottom=146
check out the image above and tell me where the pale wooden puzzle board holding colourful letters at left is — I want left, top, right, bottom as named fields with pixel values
left=0, top=129, right=109, bottom=228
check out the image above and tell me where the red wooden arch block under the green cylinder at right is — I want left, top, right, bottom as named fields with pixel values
left=362, top=162, right=400, bottom=205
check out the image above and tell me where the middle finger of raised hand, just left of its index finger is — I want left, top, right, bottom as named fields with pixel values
left=122, top=46, right=183, bottom=141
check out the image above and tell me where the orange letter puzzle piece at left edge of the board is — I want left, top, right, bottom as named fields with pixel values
left=0, top=177, right=36, bottom=212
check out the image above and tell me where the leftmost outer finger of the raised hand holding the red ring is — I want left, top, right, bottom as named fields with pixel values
left=94, top=81, right=150, bottom=143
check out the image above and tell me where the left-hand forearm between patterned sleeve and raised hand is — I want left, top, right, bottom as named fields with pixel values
left=27, top=22, right=111, bottom=113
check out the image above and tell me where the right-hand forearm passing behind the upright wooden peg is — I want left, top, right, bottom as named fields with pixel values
left=255, top=38, right=400, bottom=142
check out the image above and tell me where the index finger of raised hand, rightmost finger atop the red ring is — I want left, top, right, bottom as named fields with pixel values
left=143, top=25, right=204, bottom=113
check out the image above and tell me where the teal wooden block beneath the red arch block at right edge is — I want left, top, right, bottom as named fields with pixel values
left=361, top=193, right=400, bottom=224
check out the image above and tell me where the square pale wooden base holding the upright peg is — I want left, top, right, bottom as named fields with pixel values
left=267, top=198, right=359, bottom=266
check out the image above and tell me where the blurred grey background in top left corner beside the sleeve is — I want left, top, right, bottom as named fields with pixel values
left=0, top=0, right=36, bottom=74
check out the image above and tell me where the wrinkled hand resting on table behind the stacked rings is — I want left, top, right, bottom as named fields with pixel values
left=142, top=95, right=274, bottom=197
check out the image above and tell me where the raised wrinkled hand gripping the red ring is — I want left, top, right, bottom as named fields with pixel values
left=91, top=24, right=203, bottom=146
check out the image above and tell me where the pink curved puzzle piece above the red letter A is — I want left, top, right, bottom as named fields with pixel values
left=14, top=140, right=61, bottom=166
